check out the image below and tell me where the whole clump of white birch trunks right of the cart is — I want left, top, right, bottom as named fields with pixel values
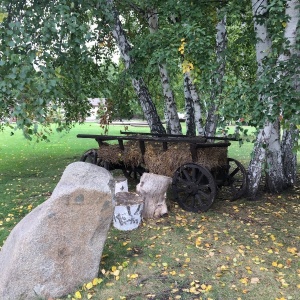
left=248, top=0, right=299, bottom=198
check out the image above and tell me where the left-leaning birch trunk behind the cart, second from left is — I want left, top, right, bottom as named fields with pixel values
left=148, top=9, right=182, bottom=134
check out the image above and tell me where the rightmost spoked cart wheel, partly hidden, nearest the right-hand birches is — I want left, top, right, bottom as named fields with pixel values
left=222, top=158, right=247, bottom=201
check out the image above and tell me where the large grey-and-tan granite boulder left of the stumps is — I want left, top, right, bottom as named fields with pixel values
left=0, top=162, right=114, bottom=300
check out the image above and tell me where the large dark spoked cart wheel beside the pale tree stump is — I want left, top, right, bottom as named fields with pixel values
left=172, top=164, right=217, bottom=213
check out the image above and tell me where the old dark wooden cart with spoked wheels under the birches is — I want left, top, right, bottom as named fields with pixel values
left=77, top=131, right=246, bottom=212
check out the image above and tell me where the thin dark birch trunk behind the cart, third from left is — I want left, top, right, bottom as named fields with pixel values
left=183, top=73, right=196, bottom=136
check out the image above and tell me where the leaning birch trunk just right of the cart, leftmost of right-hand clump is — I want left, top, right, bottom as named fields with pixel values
left=248, top=0, right=272, bottom=199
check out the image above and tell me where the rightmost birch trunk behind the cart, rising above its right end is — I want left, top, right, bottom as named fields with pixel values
left=205, top=11, right=227, bottom=137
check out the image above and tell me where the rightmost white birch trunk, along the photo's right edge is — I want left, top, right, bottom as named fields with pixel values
left=278, top=0, right=300, bottom=186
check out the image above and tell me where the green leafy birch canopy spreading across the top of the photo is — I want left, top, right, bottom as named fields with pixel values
left=0, top=0, right=300, bottom=138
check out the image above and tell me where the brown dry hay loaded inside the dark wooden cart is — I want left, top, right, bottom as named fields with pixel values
left=99, top=141, right=227, bottom=177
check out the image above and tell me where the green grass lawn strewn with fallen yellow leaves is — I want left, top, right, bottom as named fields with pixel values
left=0, top=123, right=300, bottom=300
